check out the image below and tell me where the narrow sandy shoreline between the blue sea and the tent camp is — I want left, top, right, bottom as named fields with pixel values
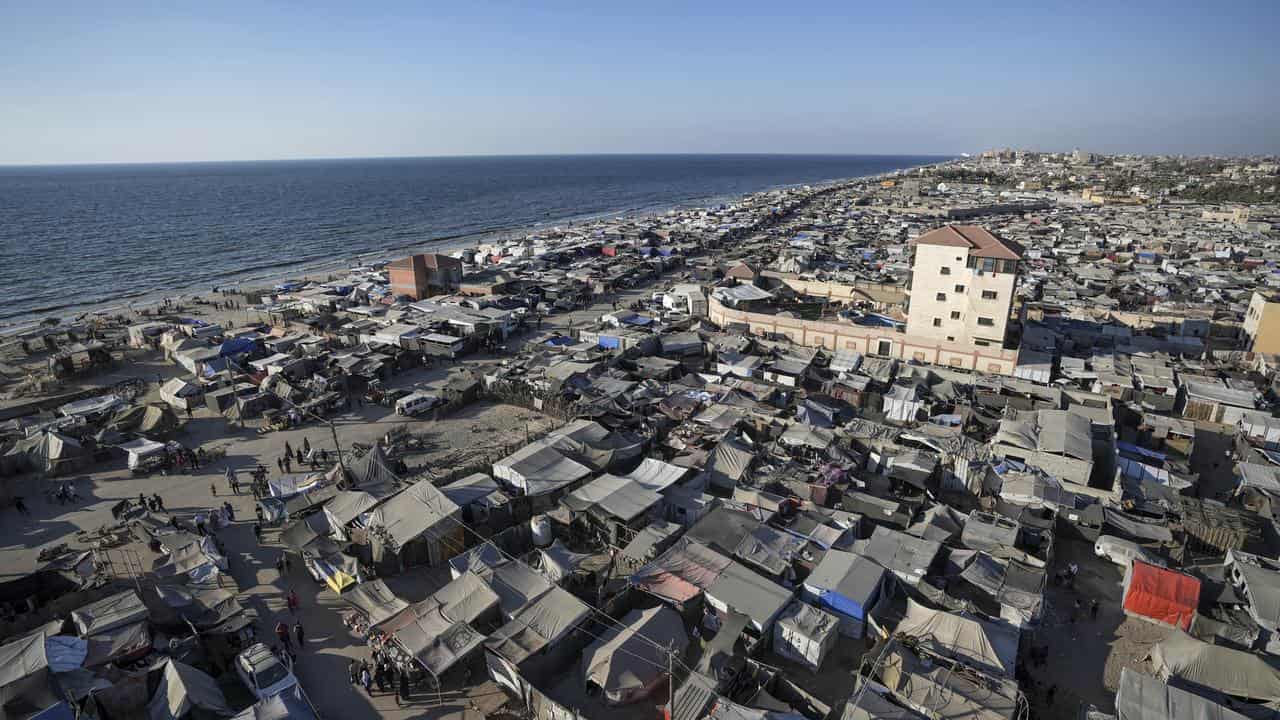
left=0, top=159, right=950, bottom=338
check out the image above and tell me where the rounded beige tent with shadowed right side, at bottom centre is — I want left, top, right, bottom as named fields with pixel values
left=582, top=606, right=689, bottom=705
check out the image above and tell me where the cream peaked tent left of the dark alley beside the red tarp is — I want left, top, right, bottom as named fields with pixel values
left=895, top=598, right=1019, bottom=678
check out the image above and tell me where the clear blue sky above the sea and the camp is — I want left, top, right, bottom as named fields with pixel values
left=0, top=0, right=1280, bottom=163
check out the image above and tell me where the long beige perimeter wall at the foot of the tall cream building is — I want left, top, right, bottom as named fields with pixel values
left=708, top=297, right=1018, bottom=375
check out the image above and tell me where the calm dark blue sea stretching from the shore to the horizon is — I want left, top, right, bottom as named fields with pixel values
left=0, top=155, right=942, bottom=324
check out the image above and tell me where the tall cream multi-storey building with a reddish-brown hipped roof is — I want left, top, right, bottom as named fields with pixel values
left=906, top=225, right=1023, bottom=347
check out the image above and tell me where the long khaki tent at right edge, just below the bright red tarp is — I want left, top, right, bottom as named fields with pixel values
left=1151, top=630, right=1280, bottom=702
